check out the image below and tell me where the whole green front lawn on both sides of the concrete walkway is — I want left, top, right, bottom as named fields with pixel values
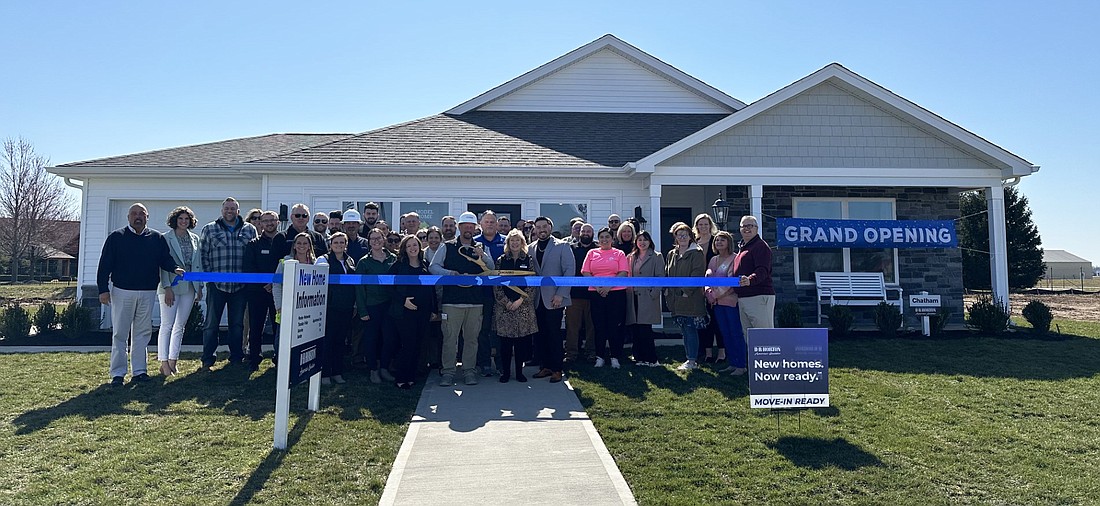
left=0, top=320, right=1100, bottom=505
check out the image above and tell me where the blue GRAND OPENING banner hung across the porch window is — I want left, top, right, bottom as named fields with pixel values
left=776, top=218, right=959, bottom=248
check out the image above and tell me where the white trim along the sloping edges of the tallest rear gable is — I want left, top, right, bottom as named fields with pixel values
left=447, top=34, right=746, bottom=114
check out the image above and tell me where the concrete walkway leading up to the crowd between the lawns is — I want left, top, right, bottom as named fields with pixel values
left=380, top=367, right=637, bottom=506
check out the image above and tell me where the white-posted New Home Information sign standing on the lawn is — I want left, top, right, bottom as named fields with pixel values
left=274, top=260, right=329, bottom=450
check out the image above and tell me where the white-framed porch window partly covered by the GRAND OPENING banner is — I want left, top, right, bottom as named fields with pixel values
left=794, top=198, right=898, bottom=284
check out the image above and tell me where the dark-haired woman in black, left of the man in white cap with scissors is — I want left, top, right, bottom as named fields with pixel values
left=389, top=235, right=436, bottom=388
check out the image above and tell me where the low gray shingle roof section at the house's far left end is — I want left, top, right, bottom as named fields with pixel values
left=58, top=133, right=351, bottom=167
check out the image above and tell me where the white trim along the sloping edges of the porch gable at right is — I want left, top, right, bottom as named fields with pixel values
left=638, top=63, right=1038, bottom=177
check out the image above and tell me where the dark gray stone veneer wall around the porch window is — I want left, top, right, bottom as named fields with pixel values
left=726, top=186, right=964, bottom=328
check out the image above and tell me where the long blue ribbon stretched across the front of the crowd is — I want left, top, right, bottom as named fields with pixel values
left=178, top=272, right=740, bottom=287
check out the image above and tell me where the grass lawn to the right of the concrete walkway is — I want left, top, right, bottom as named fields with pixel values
left=571, top=320, right=1100, bottom=505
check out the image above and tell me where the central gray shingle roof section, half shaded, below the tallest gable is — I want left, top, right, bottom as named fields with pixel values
left=254, top=111, right=728, bottom=167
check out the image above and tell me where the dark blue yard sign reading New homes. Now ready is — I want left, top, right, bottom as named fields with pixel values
left=748, top=329, right=828, bottom=408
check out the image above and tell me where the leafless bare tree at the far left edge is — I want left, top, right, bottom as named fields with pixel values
left=0, top=139, right=74, bottom=281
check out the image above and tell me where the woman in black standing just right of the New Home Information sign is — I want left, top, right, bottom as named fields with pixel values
left=317, top=232, right=355, bottom=385
